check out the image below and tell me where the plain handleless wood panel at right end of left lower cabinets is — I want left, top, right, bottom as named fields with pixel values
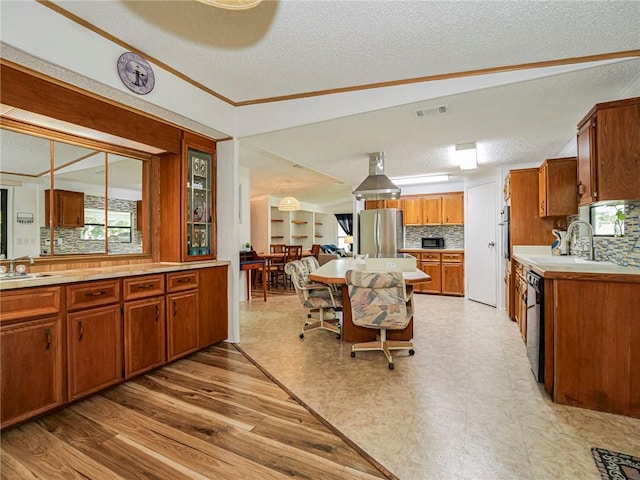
left=198, top=266, right=229, bottom=348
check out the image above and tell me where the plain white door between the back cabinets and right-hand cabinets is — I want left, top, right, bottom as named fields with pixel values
left=464, top=182, right=498, bottom=307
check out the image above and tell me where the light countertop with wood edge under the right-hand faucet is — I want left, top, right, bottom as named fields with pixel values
left=513, top=246, right=640, bottom=283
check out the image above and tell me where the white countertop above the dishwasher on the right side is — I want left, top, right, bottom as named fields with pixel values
left=513, top=246, right=640, bottom=280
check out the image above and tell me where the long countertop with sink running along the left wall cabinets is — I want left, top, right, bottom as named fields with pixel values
left=0, top=260, right=231, bottom=291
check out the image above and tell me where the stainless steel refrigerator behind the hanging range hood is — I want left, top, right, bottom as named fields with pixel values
left=358, top=208, right=404, bottom=257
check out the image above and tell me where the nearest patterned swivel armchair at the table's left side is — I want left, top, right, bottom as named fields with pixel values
left=285, top=257, right=342, bottom=338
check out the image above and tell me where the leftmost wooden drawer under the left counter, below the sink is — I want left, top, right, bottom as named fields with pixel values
left=0, top=287, right=62, bottom=323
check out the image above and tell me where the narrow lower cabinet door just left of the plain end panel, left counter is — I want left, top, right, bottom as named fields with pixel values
left=167, top=290, right=198, bottom=360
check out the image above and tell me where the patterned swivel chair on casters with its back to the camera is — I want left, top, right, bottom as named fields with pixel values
left=345, top=270, right=415, bottom=370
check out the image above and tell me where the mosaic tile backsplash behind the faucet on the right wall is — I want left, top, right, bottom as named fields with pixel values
left=567, top=201, right=640, bottom=268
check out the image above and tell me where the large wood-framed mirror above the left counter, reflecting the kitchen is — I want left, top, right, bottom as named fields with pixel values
left=0, top=117, right=151, bottom=258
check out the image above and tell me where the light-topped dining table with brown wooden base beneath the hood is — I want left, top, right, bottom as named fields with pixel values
left=309, top=258, right=431, bottom=343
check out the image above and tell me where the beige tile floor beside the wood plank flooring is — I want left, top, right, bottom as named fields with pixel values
left=240, top=295, right=640, bottom=480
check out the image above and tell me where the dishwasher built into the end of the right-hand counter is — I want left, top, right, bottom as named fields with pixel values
left=526, top=271, right=544, bottom=383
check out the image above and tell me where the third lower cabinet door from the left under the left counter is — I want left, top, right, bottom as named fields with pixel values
left=124, top=297, right=167, bottom=378
